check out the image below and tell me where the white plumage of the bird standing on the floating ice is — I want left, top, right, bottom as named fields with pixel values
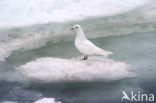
left=72, top=25, right=113, bottom=57
